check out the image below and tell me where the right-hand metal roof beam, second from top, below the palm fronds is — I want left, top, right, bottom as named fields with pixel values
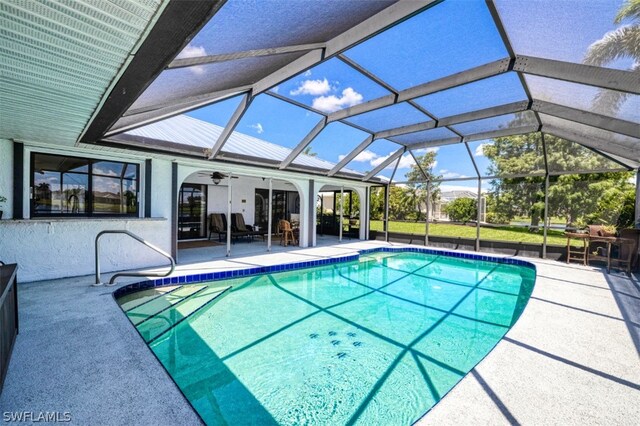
left=531, top=100, right=640, bottom=139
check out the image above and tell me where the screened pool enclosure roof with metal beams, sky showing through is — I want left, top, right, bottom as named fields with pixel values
left=2, top=0, right=640, bottom=181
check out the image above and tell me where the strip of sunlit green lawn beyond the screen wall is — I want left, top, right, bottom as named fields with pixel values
left=371, top=220, right=567, bottom=246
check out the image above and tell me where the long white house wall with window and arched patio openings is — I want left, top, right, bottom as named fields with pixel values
left=0, top=139, right=366, bottom=282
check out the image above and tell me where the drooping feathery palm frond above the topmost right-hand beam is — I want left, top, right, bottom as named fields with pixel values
left=583, top=25, right=640, bottom=66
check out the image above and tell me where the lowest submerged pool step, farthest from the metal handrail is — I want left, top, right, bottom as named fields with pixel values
left=136, top=286, right=231, bottom=343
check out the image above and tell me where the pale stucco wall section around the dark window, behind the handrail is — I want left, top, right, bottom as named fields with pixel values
left=0, top=141, right=171, bottom=281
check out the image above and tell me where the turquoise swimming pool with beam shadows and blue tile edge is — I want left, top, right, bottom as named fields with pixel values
left=117, top=250, right=535, bottom=425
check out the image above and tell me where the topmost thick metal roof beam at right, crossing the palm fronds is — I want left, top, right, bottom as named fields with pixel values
left=513, top=55, right=640, bottom=95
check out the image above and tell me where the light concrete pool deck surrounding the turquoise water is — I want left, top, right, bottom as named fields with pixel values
left=0, top=241, right=640, bottom=425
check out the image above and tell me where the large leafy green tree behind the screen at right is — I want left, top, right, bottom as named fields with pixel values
left=483, top=133, right=633, bottom=231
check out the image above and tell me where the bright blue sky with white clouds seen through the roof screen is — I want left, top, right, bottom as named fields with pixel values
left=181, top=0, right=639, bottom=181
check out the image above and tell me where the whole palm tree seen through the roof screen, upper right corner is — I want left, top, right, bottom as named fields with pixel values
left=584, top=0, right=640, bottom=113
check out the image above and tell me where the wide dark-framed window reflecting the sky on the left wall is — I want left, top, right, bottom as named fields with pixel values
left=31, top=153, right=139, bottom=217
